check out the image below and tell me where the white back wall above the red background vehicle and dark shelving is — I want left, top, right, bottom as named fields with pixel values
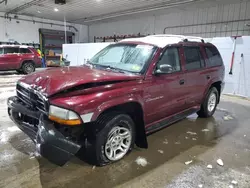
left=0, top=13, right=88, bottom=43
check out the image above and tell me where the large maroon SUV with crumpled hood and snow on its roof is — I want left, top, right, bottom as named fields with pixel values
left=8, top=35, right=224, bottom=165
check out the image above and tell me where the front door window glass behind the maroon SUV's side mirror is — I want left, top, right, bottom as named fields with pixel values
left=157, top=48, right=181, bottom=72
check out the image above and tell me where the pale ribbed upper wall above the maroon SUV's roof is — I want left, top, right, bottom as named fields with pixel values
left=89, top=1, right=250, bottom=41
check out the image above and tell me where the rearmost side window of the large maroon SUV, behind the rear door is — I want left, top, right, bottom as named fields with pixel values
left=205, top=46, right=223, bottom=67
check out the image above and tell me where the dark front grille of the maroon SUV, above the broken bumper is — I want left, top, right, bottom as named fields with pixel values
left=16, top=84, right=48, bottom=113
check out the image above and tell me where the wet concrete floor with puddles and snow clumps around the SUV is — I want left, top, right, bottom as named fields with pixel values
left=0, top=72, right=250, bottom=188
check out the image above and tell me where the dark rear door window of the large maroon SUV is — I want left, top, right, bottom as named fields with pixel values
left=184, top=47, right=205, bottom=70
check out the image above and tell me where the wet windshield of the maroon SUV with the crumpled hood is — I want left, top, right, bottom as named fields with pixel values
left=90, top=44, right=156, bottom=73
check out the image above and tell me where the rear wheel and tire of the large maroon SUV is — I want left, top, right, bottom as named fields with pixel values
left=197, top=87, right=219, bottom=118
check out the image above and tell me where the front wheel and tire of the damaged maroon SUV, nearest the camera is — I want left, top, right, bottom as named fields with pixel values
left=87, top=113, right=135, bottom=166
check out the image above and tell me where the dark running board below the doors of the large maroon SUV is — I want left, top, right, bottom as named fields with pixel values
left=146, top=108, right=199, bottom=134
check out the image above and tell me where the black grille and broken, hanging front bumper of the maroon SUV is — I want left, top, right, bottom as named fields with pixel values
left=7, top=84, right=82, bottom=166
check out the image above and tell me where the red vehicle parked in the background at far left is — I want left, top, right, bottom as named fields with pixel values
left=0, top=45, right=42, bottom=74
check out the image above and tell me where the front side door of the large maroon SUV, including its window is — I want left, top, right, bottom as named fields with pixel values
left=145, top=47, right=186, bottom=124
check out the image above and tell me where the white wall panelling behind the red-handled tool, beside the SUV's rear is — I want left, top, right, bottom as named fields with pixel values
left=206, top=36, right=250, bottom=98
